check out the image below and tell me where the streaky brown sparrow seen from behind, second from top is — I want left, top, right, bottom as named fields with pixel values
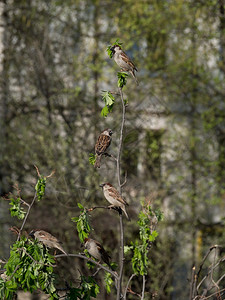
left=94, top=129, right=113, bottom=168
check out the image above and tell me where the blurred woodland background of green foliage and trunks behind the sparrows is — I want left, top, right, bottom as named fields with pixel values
left=0, top=0, right=225, bottom=300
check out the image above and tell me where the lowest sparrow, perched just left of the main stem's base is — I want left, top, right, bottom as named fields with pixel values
left=84, top=238, right=111, bottom=268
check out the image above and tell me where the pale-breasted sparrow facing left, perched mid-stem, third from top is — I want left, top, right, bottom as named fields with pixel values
left=100, top=183, right=130, bottom=221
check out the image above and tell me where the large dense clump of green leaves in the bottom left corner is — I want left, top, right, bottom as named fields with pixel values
left=0, top=237, right=58, bottom=300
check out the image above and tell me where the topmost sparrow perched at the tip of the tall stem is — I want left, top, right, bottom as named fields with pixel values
left=110, top=45, right=139, bottom=85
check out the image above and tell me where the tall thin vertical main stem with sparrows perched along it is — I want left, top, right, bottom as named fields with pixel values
left=116, top=88, right=126, bottom=300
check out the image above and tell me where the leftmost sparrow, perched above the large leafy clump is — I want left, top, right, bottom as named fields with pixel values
left=29, top=230, right=67, bottom=255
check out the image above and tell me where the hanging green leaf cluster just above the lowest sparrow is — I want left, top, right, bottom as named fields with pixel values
left=71, top=203, right=91, bottom=243
